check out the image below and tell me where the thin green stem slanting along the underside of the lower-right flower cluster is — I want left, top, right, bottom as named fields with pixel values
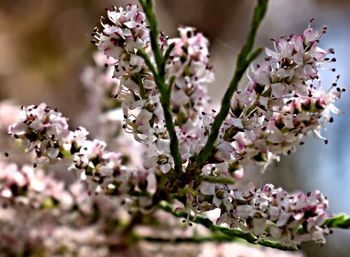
left=157, top=201, right=298, bottom=251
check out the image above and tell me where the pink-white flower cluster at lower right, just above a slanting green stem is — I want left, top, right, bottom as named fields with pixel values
left=199, top=184, right=330, bottom=245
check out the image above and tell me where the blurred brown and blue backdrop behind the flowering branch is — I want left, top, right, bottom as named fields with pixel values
left=0, top=0, right=350, bottom=257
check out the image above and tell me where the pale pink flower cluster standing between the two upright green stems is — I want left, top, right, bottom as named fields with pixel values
left=166, top=27, right=214, bottom=126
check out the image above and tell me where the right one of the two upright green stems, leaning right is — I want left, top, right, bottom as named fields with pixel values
left=195, top=0, right=268, bottom=167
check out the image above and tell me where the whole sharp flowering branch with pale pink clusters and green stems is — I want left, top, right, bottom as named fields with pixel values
left=0, top=0, right=350, bottom=254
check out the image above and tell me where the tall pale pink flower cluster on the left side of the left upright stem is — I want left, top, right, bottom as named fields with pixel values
left=95, top=5, right=172, bottom=172
